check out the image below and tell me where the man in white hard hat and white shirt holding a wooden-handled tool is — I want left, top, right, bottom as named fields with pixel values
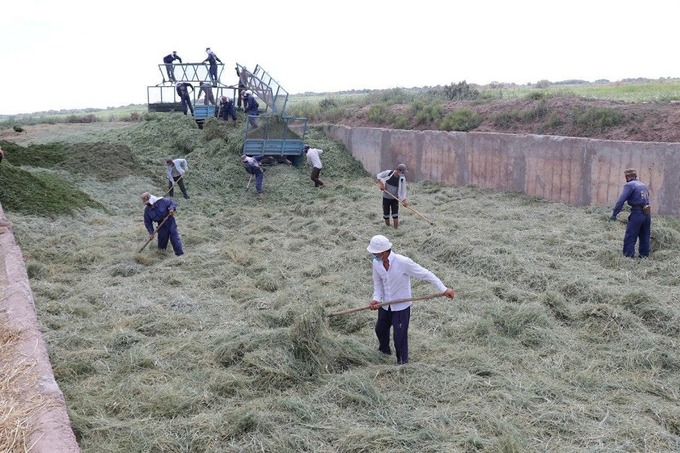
left=366, top=234, right=454, bottom=365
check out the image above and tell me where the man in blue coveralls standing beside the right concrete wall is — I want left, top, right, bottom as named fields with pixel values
left=609, top=168, right=652, bottom=258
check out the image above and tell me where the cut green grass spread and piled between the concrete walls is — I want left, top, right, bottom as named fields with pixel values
left=0, top=114, right=680, bottom=453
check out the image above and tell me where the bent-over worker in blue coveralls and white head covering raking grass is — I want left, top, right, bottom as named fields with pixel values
left=142, top=192, right=184, bottom=256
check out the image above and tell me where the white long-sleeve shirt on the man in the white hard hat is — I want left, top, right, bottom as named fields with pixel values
left=373, top=252, right=446, bottom=311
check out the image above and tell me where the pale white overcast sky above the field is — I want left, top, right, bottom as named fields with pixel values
left=0, top=0, right=680, bottom=115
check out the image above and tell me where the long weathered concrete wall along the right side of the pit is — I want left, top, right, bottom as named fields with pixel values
left=324, top=125, right=680, bottom=217
